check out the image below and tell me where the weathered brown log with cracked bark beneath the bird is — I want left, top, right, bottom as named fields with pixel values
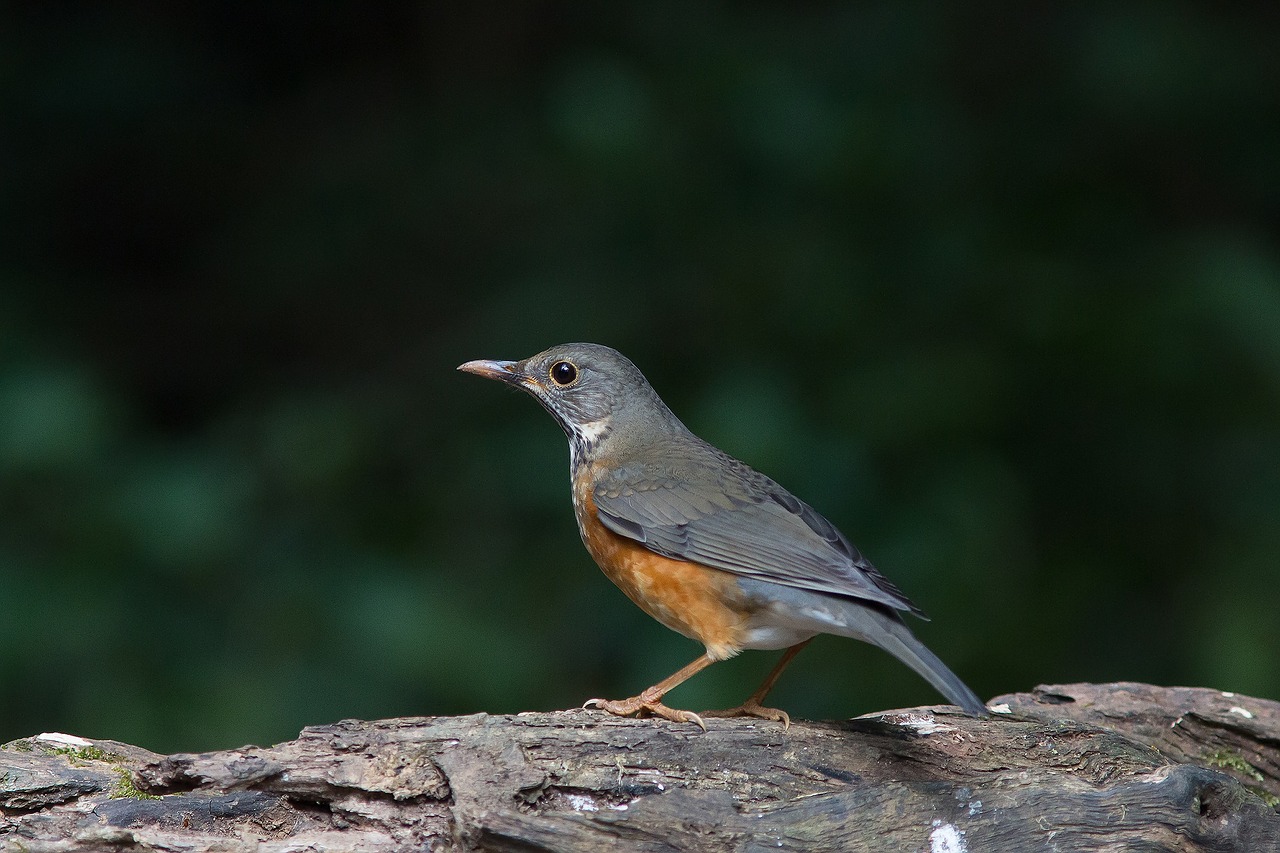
left=0, top=683, right=1280, bottom=853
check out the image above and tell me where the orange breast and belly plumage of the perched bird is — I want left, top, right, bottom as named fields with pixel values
left=573, top=466, right=749, bottom=660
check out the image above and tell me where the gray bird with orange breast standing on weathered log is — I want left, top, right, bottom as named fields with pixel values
left=457, top=343, right=987, bottom=730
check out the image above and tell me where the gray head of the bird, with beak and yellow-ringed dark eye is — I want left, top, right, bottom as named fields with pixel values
left=458, top=343, right=685, bottom=453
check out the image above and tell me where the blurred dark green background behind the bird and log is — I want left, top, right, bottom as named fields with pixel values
left=0, top=0, right=1280, bottom=751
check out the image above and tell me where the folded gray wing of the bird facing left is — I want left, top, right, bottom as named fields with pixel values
left=593, top=451, right=923, bottom=616
